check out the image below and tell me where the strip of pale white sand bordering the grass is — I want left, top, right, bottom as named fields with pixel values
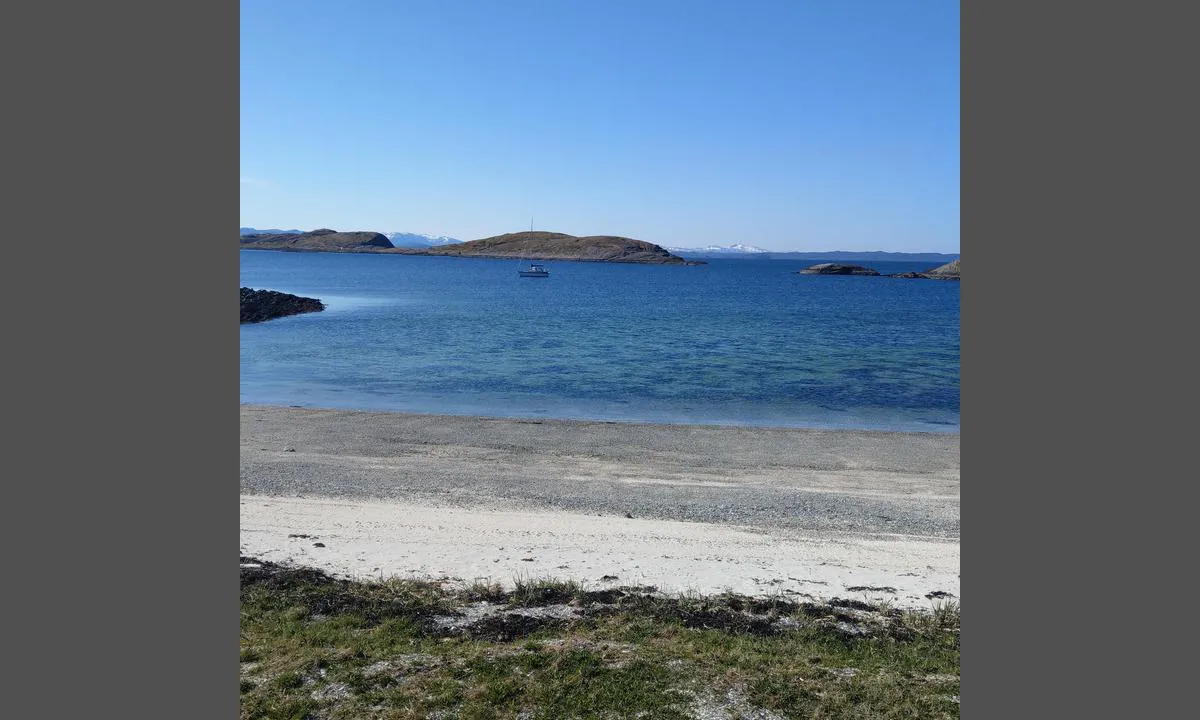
left=241, top=494, right=960, bottom=607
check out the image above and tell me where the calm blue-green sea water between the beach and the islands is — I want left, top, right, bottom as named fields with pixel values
left=241, top=251, right=959, bottom=432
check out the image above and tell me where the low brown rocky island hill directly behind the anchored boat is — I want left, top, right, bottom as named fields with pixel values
left=395, top=230, right=700, bottom=265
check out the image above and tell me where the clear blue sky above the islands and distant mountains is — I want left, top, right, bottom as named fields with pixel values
left=240, top=0, right=959, bottom=253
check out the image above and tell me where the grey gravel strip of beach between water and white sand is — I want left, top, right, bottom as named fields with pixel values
left=241, top=406, right=959, bottom=539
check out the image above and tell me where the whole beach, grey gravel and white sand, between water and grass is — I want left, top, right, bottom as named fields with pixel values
left=240, top=406, right=960, bottom=607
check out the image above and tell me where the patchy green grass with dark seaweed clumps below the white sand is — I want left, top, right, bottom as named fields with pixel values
left=240, top=558, right=960, bottom=720
